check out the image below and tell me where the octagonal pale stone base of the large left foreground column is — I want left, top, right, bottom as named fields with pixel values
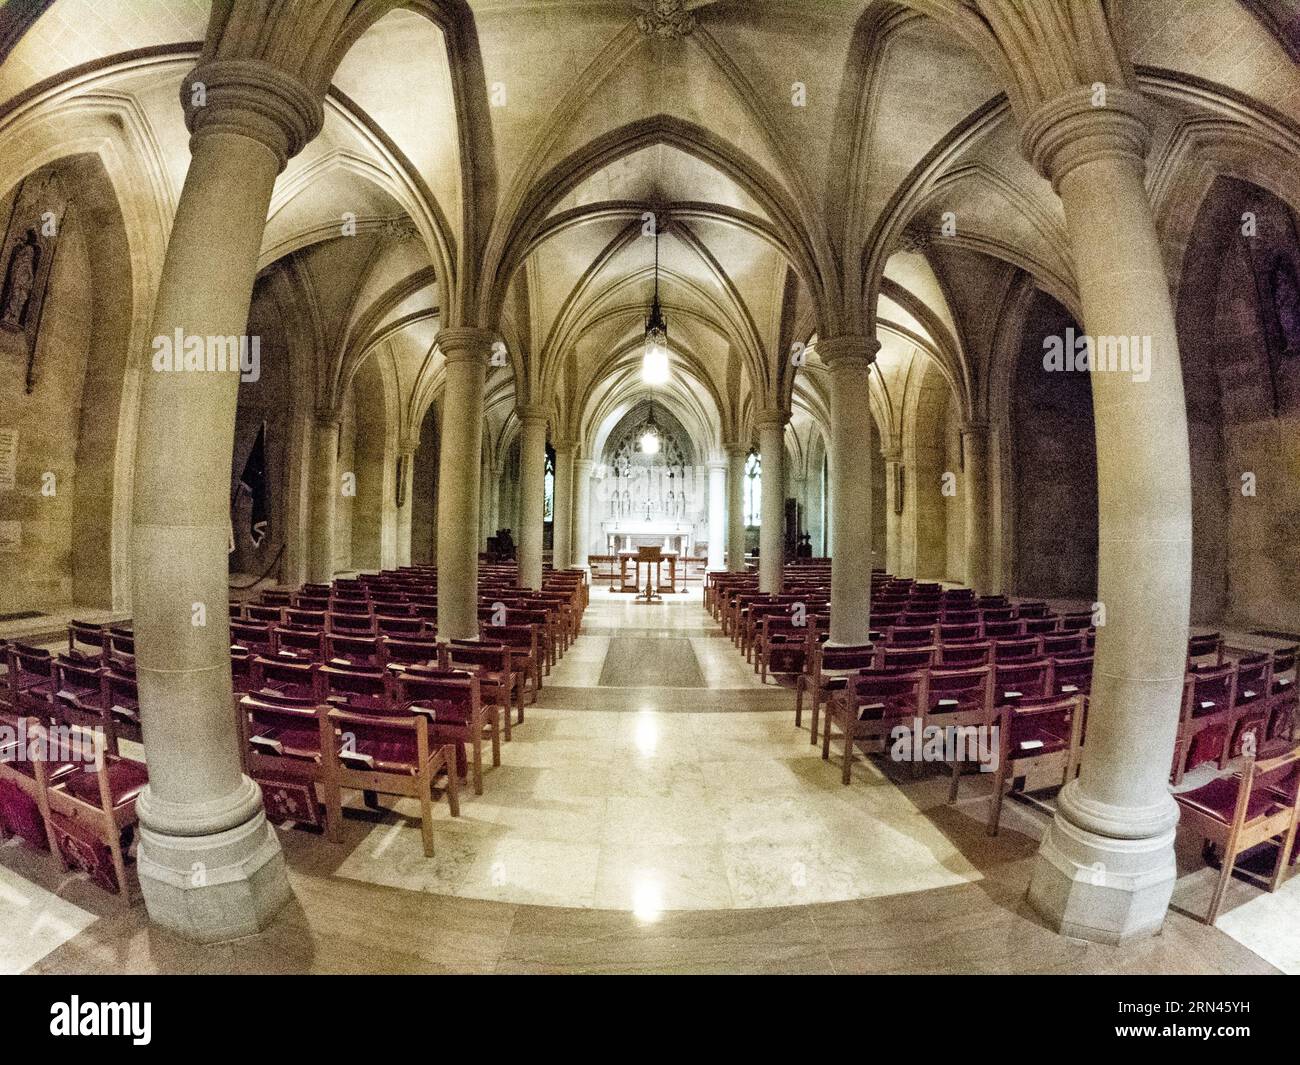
left=138, top=808, right=293, bottom=943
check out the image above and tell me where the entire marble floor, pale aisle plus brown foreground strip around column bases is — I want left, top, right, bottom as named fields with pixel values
left=0, top=588, right=1300, bottom=973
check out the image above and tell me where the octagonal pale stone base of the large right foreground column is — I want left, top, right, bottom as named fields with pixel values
left=1030, top=813, right=1178, bottom=944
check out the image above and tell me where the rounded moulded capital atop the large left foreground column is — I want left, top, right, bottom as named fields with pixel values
left=181, top=59, right=325, bottom=170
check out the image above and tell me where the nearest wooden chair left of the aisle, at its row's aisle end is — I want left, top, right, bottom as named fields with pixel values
left=321, top=709, right=460, bottom=858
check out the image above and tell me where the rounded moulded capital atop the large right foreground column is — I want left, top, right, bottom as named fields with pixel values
left=1021, top=87, right=1151, bottom=191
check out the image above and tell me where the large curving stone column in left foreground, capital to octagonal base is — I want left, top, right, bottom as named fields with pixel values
left=133, top=61, right=322, bottom=941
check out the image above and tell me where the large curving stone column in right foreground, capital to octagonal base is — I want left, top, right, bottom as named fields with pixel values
left=1023, top=88, right=1192, bottom=943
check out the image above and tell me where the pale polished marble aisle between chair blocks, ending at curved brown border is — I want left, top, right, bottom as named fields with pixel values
left=333, top=588, right=980, bottom=915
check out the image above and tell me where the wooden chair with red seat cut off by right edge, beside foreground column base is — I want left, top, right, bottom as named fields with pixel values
left=1174, top=748, right=1300, bottom=925
